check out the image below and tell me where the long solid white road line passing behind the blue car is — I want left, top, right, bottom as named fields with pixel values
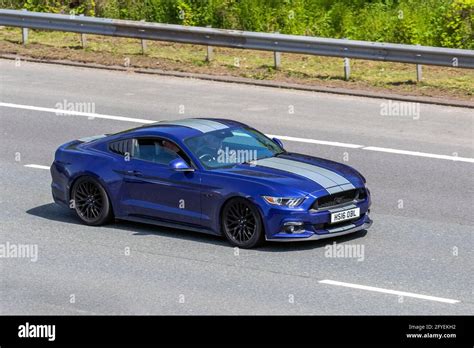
left=0, top=102, right=474, bottom=163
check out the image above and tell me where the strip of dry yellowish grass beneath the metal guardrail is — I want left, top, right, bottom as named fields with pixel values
left=0, top=28, right=474, bottom=100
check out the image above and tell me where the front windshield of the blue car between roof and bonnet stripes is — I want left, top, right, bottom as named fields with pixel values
left=185, top=127, right=284, bottom=169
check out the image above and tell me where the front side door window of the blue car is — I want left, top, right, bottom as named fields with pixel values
left=133, top=138, right=188, bottom=165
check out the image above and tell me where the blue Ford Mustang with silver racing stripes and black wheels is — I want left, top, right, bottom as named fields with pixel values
left=51, top=118, right=372, bottom=248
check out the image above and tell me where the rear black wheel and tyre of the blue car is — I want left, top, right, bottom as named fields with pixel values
left=71, top=176, right=112, bottom=226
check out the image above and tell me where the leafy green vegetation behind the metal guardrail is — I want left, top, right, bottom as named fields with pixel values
left=0, top=0, right=474, bottom=49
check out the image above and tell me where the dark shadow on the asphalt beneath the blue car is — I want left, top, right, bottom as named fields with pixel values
left=26, top=203, right=367, bottom=252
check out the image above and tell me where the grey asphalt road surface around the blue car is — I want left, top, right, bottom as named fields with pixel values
left=0, top=60, right=474, bottom=315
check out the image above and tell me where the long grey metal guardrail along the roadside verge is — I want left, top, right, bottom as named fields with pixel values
left=0, top=9, right=474, bottom=69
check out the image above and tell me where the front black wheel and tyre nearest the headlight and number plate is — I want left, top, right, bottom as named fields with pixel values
left=221, top=198, right=265, bottom=249
